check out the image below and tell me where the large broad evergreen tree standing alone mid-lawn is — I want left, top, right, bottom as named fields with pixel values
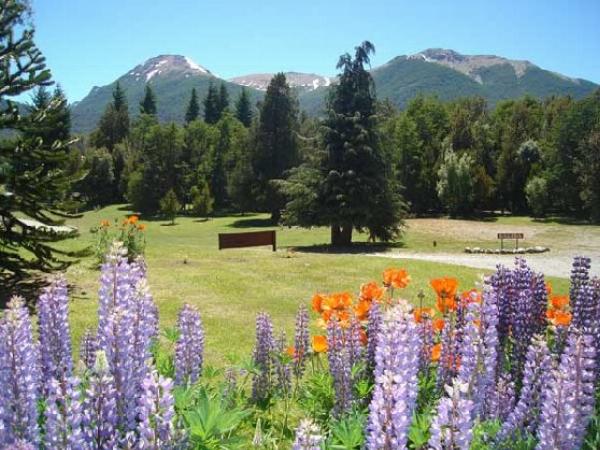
left=280, top=42, right=404, bottom=245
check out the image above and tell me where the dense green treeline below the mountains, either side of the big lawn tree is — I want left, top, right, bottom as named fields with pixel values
left=71, top=78, right=600, bottom=222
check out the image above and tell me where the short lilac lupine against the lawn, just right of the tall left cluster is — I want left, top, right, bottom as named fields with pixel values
left=175, top=303, right=204, bottom=384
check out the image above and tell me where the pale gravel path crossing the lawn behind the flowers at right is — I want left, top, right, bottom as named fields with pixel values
left=370, top=251, right=600, bottom=278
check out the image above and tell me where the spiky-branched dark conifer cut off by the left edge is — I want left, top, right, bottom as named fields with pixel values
left=0, top=1, right=83, bottom=295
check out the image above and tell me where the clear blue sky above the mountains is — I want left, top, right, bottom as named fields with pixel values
left=32, top=0, right=600, bottom=101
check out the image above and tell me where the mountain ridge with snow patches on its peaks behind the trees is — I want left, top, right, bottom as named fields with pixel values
left=71, top=48, right=598, bottom=132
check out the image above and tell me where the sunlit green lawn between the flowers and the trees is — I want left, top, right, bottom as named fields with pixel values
left=56, top=206, right=567, bottom=365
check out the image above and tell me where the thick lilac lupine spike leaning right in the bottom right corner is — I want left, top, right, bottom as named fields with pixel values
left=536, top=329, right=596, bottom=450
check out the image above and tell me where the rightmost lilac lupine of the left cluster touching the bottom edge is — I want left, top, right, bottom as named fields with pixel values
left=136, top=371, right=175, bottom=450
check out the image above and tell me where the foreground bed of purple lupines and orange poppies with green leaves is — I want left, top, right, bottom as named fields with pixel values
left=0, top=244, right=600, bottom=449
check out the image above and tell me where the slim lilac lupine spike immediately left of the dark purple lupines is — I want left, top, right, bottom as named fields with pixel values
left=479, top=280, right=502, bottom=418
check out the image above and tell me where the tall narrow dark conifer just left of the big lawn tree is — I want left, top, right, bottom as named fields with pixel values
left=254, top=73, right=299, bottom=223
